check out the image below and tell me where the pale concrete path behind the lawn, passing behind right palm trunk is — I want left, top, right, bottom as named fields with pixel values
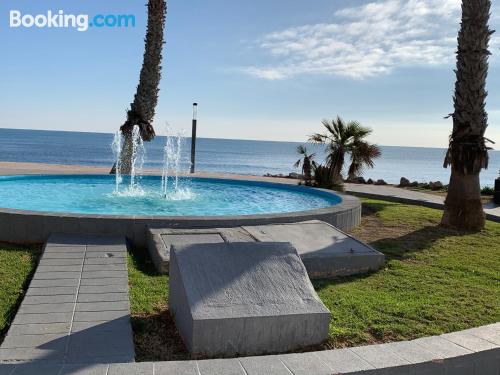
left=345, top=184, right=500, bottom=221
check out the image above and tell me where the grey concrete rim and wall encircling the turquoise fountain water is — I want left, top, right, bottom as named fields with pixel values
left=0, top=174, right=361, bottom=246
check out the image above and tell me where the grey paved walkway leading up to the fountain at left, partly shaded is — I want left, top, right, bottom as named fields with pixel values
left=0, top=235, right=134, bottom=364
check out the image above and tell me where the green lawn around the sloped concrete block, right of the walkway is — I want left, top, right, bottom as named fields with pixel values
left=129, top=199, right=500, bottom=360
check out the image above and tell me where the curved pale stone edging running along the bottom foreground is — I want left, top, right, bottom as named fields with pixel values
left=0, top=323, right=500, bottom=375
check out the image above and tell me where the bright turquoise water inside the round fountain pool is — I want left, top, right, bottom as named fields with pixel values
left=0, top=175, right=342, bottom=216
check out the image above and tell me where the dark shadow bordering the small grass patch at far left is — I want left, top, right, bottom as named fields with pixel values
left=0, top=242, right=42, bottom=344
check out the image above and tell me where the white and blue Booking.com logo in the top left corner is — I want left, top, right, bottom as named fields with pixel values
left=10, top=10, right=135, bottom=31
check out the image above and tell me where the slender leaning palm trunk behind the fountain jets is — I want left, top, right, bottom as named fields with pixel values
left=114, top=0, right=167, bottom=174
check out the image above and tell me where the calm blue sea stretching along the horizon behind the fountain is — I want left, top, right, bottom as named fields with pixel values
left=0, top=128, right=500, bottom=186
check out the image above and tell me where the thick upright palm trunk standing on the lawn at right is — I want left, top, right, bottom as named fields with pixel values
left=441, top=0, right=493, bottom=231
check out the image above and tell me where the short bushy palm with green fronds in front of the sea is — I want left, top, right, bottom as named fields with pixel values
left=309, top=116, right=381, bottom=183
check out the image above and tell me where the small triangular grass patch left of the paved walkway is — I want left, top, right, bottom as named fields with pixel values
left=0, top=243, right=39, bottom=342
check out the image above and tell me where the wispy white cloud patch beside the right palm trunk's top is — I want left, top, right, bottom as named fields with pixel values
left=243, top=0, right=497, bottom=80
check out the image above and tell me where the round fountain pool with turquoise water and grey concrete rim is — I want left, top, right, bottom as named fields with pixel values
left=0, top=175, right=361, bottom=247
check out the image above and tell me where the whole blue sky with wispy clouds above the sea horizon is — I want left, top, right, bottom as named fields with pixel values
left=0, top=0, right=500, bottom=147
